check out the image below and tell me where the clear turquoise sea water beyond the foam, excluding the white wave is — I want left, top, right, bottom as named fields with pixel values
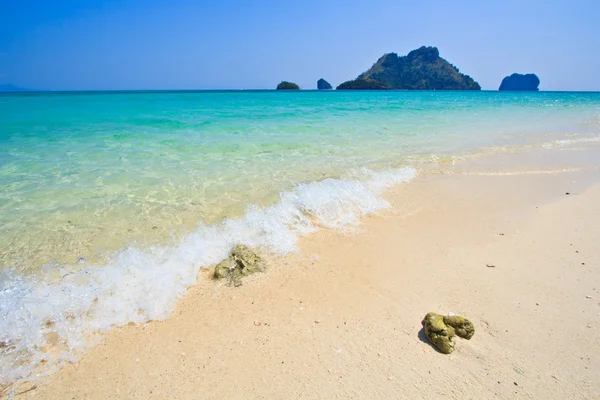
left=0, top=92, right=599, bottom=271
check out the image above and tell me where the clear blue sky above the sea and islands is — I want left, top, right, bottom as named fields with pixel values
left=0, top=0, right=600, bottom=90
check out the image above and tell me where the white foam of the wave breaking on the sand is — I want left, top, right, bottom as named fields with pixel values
left=0, top=167, right=416, bottom=384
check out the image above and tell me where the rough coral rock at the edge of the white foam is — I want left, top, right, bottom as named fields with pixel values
left=213, top=244, right=265, bottom=286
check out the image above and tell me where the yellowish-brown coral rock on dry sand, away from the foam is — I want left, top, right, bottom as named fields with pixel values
left=421, top=313, right=475, bottom=354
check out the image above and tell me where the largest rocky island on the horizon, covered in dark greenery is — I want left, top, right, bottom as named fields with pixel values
left=337, top=46, right=481, bottom=90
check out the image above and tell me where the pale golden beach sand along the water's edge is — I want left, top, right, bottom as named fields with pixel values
left=11, top=145, right=600, bottom=399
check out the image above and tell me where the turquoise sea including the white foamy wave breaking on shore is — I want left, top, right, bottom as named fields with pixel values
left=0, top=91, right=600, bottom=383
